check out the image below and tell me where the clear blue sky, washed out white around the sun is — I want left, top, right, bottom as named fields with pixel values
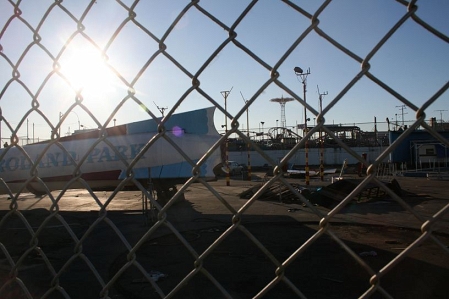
left=0, top=0, right=449, bottom=143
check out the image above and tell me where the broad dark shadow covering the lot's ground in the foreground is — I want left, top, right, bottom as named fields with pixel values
left=0, top=201, right=449, bottom=298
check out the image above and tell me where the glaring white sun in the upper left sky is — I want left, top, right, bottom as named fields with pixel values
left=61, top=48, right=115, bottom=102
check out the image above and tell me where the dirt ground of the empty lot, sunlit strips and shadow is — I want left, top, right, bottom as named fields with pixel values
left=0, top=178, right=449, bottom=299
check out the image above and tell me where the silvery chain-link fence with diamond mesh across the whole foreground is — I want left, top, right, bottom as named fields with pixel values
left=0, top=0, right=449, bottom=298
